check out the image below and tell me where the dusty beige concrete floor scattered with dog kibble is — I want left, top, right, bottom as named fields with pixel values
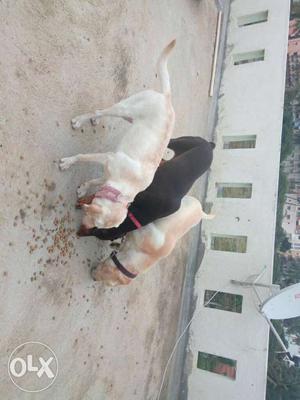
left=0, top=0, right=217, bottom=400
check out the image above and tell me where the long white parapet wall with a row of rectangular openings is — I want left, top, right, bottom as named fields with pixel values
left=188, top=0, right=290, bottom=400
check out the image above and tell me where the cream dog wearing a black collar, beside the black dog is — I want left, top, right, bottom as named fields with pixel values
left=92, top=196, right=214, bottom=286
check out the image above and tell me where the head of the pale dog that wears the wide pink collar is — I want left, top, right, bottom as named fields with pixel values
left=82, top=201, right=127, bottom=229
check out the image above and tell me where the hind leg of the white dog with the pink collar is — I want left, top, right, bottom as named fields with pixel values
left=71, top=102, right=133, bottom=129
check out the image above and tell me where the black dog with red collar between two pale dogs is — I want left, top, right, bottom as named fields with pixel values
left=78, top=136, right=215, bottom=240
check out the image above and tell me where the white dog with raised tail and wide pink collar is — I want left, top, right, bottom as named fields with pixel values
left=60, top=40, right=175, bottom=228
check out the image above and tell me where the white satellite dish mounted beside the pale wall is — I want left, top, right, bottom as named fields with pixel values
left=261, top=283, right=300, bottom=319
